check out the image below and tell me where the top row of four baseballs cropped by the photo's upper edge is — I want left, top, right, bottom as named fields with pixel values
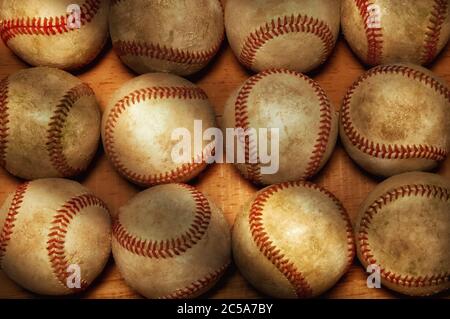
left=0, top=0, right=450, bottom=75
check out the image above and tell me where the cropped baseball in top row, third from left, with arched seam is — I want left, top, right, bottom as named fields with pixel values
left=225, top=0, right=340, bottom=72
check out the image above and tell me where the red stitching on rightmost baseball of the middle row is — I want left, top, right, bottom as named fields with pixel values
left=341, top=65, right=450, bottom=161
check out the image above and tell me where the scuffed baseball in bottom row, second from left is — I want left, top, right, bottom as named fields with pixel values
left=112, top=184, right=231, bottom=299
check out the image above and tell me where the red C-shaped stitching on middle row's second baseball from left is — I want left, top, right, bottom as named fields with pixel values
left=105, top=86, right=214, bottom=186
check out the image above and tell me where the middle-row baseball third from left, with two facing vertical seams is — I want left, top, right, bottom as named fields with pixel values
left=223, top=69, right=338, bottom=185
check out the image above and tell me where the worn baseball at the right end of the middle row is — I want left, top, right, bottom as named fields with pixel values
left=340, top=64, right=450, bottom=176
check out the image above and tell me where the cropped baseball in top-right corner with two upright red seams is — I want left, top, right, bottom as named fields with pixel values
left=341, top=0, right=450, bottom=66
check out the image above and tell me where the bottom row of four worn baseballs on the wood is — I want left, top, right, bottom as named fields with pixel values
left=0, top=173, right=450, bottom=298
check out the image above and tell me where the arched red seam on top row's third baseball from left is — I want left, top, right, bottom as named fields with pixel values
left=239, top=14, right=335, bottom=68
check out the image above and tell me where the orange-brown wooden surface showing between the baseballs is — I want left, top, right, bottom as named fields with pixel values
left=0, top=20, right=450, bottom=298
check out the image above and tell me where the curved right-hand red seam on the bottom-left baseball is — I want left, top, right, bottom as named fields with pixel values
left=47, top=194, right=108, bottom=290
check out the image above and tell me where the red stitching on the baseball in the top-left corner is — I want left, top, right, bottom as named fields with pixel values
left=0, top=0, right=102, bottom=43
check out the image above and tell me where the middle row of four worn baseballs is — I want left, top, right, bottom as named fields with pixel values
left=0, top=64, right=450, bottom=186
